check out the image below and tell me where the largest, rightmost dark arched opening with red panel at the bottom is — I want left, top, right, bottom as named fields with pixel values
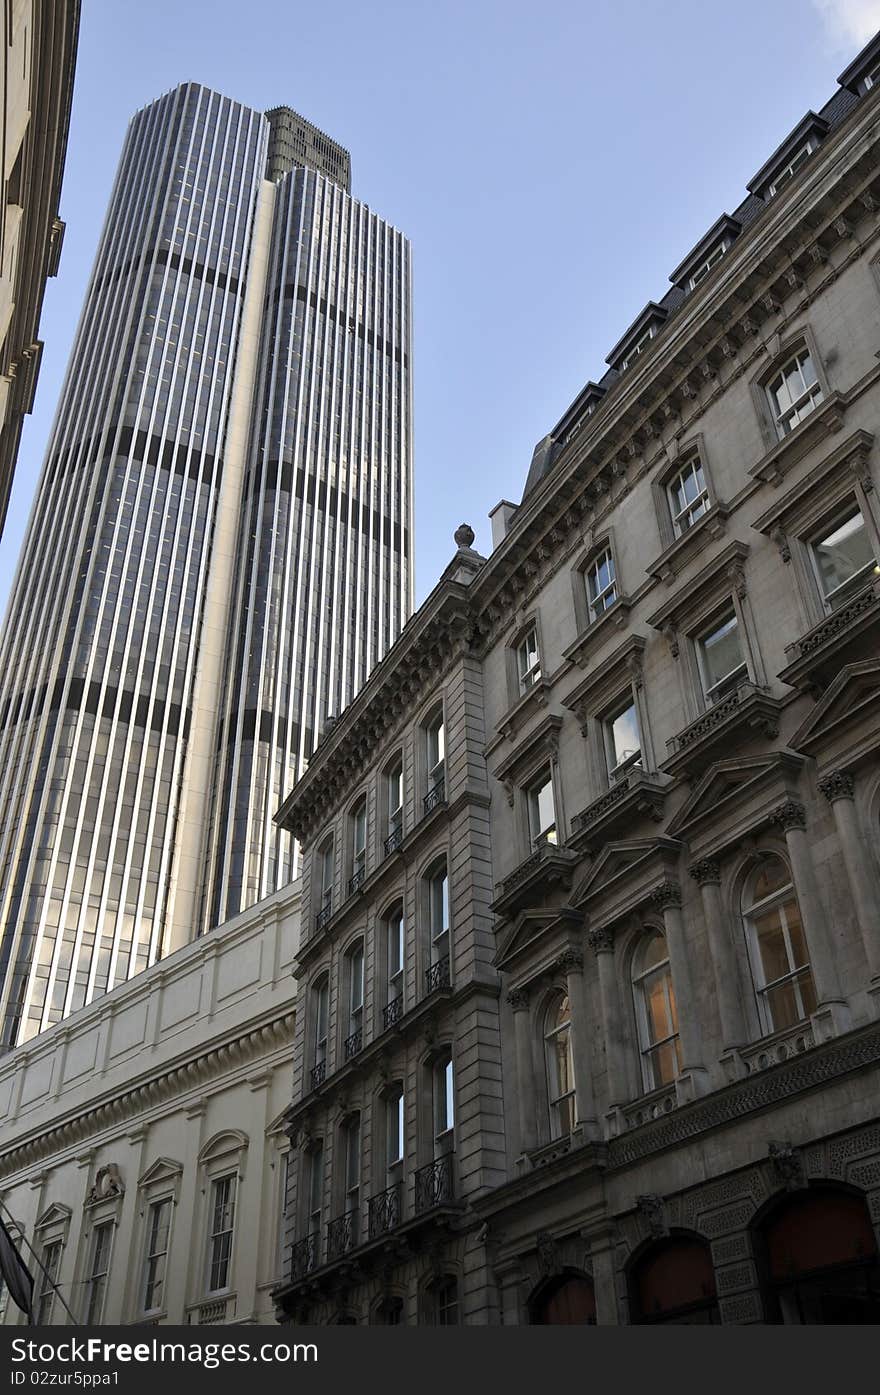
left=756, top=1184, right=880, bottom=1327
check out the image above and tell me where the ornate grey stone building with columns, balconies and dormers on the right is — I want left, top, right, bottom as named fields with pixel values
left=276, top=27, right=880, bottom=1324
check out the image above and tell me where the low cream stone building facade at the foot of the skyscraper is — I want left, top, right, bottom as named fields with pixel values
left=0, top=883, right=298, bottom=1327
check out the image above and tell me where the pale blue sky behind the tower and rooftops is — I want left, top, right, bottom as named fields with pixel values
left=0, top=0, right=880, bottom=608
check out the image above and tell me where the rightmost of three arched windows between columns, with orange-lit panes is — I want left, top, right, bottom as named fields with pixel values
left=742, top=854, right=816, bottom=1032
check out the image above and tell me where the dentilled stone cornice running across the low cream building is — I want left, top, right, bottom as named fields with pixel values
left=0, top=1011, right=296, bottom=1177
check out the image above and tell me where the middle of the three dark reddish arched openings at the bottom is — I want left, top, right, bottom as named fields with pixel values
left=629, top=1233, right=721, bottom=1324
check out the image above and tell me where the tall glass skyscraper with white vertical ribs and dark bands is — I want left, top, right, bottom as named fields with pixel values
left=0, top=84, right=411, bottom=1046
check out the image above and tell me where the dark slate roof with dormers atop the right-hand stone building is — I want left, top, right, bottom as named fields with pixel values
left=523, top=31, right=880, bottom=501
